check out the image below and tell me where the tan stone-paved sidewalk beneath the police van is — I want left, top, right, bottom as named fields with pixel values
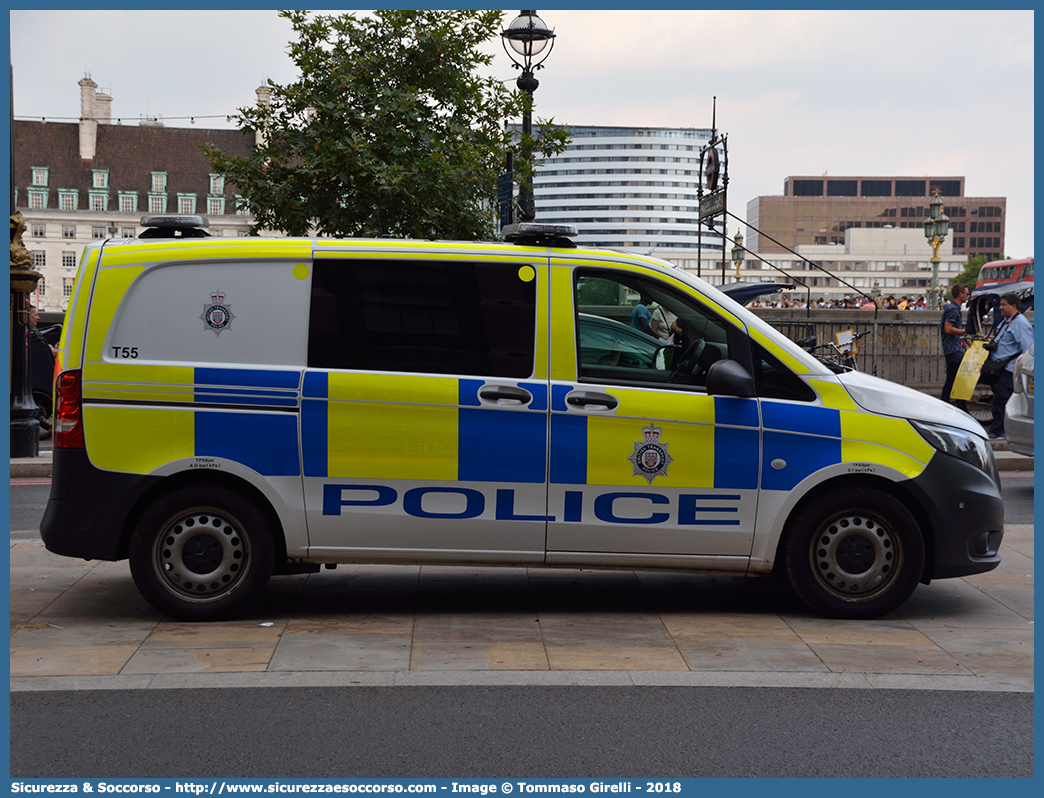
left=10, top=525, right=1034, bottom=691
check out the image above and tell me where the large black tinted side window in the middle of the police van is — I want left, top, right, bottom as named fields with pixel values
left=308, top=258, right=537, bottom=377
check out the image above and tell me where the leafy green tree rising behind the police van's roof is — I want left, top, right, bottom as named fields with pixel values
left=204, top=10, right=568, bottom=240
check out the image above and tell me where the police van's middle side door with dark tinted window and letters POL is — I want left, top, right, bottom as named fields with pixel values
left=301, top=253, right=548, bottom=562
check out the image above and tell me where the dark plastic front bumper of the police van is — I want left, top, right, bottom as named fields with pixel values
left=903, top=452, right=1004, bottom=582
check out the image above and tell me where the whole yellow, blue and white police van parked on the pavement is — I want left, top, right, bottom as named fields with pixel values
left=42, top=217, right=1003, bottom=619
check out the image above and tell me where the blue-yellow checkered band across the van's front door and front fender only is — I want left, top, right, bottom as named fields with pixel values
left=549, top=384, right=934, bottom=491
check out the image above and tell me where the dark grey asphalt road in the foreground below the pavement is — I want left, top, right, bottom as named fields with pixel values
left=10, top=686, right=1034, bottom=778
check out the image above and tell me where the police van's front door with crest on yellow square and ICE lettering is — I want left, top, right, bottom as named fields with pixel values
left=548, top=266, right=760, bottom=559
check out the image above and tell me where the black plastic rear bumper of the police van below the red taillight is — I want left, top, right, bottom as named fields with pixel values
left=40, top=449, right=159, bottom=560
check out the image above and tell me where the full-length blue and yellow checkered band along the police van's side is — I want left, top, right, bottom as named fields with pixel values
left=84, top=362, right=934, bottom=490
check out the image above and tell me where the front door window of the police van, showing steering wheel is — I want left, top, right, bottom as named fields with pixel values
left=574, top=271, right=730, bottom=390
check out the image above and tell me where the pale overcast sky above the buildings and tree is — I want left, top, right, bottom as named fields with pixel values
left=10, top=7, right=1035, bottom=257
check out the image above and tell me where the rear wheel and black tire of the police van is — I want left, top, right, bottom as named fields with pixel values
left=131, top=486, right=276, bottom=620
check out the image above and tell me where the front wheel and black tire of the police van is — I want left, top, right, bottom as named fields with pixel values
left=784, top=488, right=924, bottom=618
